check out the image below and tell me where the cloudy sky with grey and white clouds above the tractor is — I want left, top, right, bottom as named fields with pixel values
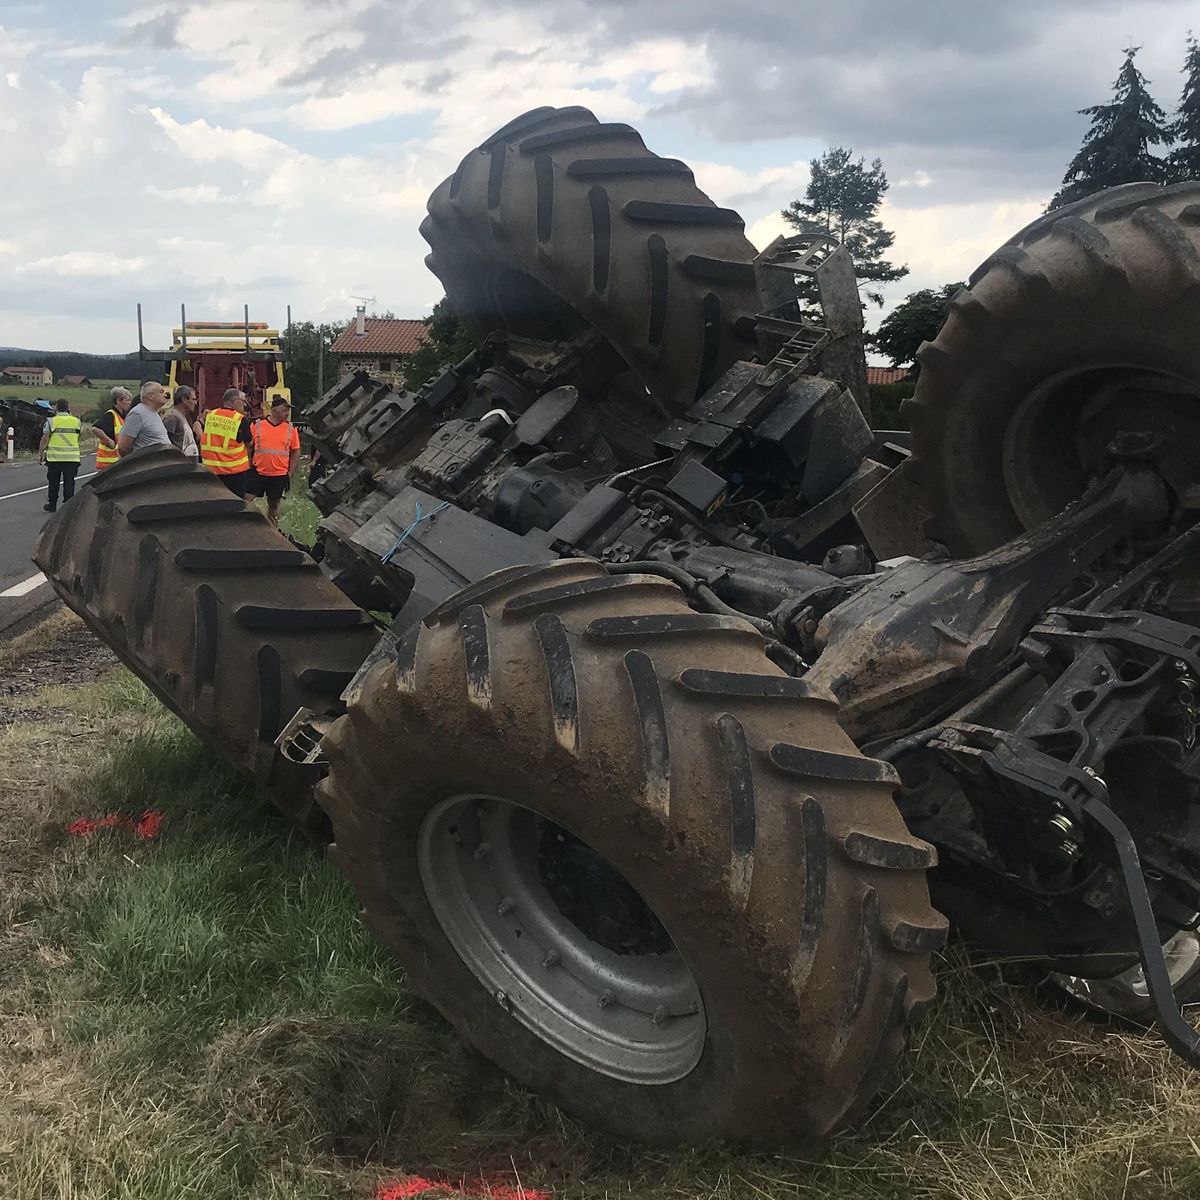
left=0, top=0, right=1196, bottom=353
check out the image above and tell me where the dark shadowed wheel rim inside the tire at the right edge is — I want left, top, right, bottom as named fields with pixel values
left=1002, top=365, right=1200, bottom=528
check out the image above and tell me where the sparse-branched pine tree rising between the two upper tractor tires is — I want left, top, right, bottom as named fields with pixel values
left=781, top=146, right=908, bottom=304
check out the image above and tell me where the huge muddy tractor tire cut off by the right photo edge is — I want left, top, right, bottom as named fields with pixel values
left=905, top=184, right=1200, bottom=556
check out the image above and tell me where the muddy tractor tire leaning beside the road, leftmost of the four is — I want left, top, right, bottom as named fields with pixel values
left=35, top=449, right=378, bottom=836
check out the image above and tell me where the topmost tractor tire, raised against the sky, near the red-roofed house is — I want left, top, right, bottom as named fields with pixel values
left=421, top=108, right=760, bottom=412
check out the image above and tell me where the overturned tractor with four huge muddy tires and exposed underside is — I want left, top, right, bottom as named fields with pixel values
left=37, top=109, right=1200, bottom=1141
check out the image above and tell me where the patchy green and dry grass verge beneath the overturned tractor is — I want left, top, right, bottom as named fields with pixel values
left=0, top=618, right=1200, bottom=1200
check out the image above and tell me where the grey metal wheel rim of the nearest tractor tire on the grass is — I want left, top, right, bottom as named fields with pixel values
left=418, top=794, right=707, bottom=1084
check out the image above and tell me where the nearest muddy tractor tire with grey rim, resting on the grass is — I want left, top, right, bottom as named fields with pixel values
left=318, top=560, right=946, bottom=1144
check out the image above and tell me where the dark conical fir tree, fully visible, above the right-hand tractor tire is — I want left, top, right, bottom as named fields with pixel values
left=1050, top=46, right=1171, bottom=209
